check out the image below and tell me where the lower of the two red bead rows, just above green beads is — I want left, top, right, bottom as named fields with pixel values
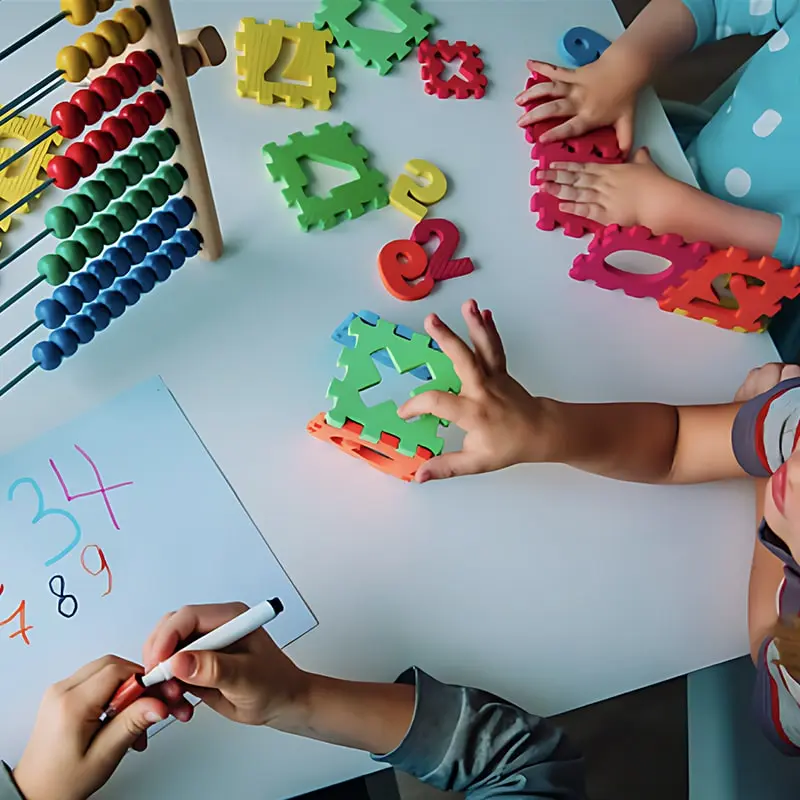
left=47, top=92, right=167, bottom=189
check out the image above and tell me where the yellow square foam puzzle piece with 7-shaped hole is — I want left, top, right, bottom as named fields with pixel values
left=236, top=17, right=336, bottom=111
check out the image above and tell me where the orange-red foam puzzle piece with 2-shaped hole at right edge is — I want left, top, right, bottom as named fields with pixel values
left=659, top=247, right=800, bottom=333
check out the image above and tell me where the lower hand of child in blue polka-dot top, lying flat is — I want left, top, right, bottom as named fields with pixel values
left=536, top=148, right=687, bottom=234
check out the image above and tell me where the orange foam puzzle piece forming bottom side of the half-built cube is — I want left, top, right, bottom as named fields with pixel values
left=306, top=411, right=433, bottom=483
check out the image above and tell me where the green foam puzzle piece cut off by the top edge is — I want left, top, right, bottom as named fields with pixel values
left=314, top=0, right=436, bottom=75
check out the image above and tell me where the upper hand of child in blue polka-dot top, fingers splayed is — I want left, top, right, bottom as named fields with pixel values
left=516, top=58, right=638, bottom=153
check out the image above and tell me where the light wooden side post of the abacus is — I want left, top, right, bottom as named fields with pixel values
left=137, top=0, right=222, bottom=261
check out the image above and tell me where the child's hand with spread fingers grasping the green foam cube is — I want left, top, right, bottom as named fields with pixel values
left=398, top=300, right=552, bottom=483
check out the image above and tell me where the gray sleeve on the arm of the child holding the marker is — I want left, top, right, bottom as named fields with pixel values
left=373, top=668, right=586, bottom=800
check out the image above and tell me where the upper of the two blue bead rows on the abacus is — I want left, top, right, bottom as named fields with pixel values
left=35, top=197, right=195, bottom=330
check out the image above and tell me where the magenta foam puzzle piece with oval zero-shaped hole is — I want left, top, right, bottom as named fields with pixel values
left=569, top=225, right=712, bottom=300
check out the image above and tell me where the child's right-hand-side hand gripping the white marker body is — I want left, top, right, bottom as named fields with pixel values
left=143, top=603, right=308, bottom=726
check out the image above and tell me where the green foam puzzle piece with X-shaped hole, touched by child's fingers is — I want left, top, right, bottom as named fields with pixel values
left=326, top=317, right=461, bottom=456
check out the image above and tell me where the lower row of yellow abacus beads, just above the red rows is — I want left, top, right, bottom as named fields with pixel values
left=56, top=8, right=147, bottom=83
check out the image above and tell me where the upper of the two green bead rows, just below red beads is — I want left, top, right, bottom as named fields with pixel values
left=44, top=130, right=182, bottom=239
